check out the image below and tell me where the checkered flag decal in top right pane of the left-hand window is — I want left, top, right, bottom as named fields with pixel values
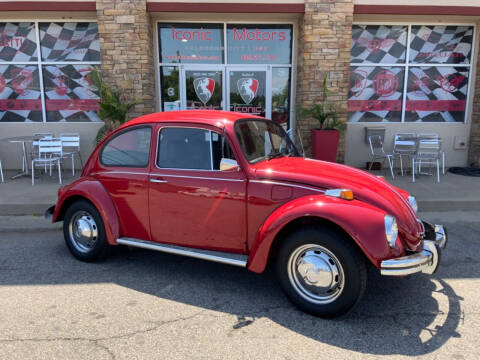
left=40, top=23, right=100, bottom=61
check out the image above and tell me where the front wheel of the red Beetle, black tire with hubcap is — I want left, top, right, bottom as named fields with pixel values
left=277, top=226, right=367, bottom=318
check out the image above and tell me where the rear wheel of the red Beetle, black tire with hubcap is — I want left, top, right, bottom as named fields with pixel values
left=63, top=200, right=110, bottom=262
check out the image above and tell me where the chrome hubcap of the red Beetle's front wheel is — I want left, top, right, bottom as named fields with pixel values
left=288, top=244, right=344, bottom=304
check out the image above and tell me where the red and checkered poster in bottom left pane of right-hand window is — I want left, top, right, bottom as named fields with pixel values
left=348, top=66, right=405, bottom=122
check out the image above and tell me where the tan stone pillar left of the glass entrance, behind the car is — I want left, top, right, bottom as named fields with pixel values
left=96, top=0, right=155, bottom=118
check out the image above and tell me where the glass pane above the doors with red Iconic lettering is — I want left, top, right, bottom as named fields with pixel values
left=158, top=23, right=224, bottom=64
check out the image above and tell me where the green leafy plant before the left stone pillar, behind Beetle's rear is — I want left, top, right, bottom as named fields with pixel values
left=89, top=70, right=138, bottom=144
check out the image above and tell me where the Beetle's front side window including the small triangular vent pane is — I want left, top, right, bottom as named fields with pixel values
left=157, top=127, right=235, bottom=170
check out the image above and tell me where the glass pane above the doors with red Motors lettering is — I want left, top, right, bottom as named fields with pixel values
left=227, top=24, right=292, bottom=64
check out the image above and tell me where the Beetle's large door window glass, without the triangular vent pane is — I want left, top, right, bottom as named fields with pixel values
left=157, top=127, right=212, bottom=170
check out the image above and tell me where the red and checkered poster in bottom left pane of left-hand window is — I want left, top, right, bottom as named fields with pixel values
left=0, top=65, right=42, bottom=122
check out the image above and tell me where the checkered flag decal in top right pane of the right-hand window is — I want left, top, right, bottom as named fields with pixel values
left=409, top=25, right=473, bottom=64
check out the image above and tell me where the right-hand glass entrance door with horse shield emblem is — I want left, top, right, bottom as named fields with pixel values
left=227, top=66, right=272, bottom=118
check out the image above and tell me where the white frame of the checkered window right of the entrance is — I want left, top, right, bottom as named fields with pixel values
left=347, top=21, right=477, bottom=126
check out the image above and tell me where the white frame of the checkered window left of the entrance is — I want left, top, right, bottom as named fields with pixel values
left=0, top=18, right=103, bottom=124
